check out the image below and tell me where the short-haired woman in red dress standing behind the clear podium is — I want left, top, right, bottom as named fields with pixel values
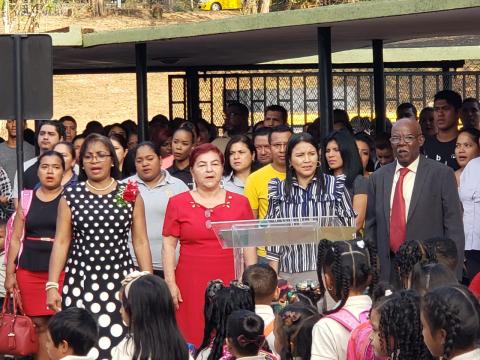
left=163, top=143, right=257, bottom=347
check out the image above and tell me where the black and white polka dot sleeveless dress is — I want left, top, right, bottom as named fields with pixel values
left=62, top=182, right=134, bottom=359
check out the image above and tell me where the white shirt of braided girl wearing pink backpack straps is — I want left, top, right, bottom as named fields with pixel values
left=311, top=295, right=372, bottom=360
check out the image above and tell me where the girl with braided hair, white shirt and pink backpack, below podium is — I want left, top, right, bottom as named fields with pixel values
left=311, top=240, right=377, bottom=360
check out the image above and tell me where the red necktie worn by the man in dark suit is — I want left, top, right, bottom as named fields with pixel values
left=390, top=168, right=410, bottom=252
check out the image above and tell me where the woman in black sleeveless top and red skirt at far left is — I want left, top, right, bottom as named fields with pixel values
left=5, top=151, right=65, bottom=360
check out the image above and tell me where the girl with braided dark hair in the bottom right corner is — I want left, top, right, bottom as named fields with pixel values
left=421, top=285, right=480, bottom=360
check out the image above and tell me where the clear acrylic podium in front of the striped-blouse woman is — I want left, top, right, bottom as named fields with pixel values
left=212, top=216, right=355, bottom=279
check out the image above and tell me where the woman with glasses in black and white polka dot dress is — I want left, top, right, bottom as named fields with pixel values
left=47, top=134, right=152, bottom=359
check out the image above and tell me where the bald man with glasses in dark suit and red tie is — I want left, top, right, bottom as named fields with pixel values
left=365, top=118, right=465, bottom=281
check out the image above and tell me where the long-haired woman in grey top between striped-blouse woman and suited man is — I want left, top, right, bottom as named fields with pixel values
left=322, top=130, right=368, bottom=231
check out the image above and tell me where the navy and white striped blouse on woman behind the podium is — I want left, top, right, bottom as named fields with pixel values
left=265, top=174, right=355, bottom=273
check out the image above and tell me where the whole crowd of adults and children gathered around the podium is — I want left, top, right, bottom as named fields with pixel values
left=0, top=90, right=480, bottom=360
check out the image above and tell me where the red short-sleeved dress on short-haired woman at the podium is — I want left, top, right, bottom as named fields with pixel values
left=163, top=191, right=253, bottom=347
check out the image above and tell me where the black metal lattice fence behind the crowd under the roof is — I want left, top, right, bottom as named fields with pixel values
left=169, top=67, right=480, bottom=126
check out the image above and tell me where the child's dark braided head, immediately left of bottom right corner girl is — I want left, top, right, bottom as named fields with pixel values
left=370, top=290, right=432, bottom=360
